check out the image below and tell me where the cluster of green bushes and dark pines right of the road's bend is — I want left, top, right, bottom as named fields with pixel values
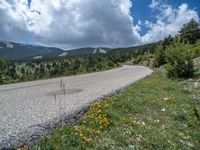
left=133, top=19, right=200, bottom=78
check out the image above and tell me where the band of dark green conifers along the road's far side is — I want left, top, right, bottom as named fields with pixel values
left=0, top=43, right=157, bottom=84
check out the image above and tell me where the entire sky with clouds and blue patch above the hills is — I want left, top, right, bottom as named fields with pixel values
left=0, top=0, right=200, bottom=49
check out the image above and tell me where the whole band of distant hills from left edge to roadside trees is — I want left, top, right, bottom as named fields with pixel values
left=0, top=41, right=157, bottom=60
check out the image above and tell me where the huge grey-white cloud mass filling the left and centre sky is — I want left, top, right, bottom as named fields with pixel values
left=0, top=0, right=140, bottom=48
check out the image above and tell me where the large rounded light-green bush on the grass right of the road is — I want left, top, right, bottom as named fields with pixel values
left=166, top=43, right=194, bottom=78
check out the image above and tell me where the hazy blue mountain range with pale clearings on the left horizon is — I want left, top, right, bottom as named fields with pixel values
left=0, top=41, right=111, bottom=60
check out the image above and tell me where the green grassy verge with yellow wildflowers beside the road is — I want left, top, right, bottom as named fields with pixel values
left=28, top=70, right=200, bottom=150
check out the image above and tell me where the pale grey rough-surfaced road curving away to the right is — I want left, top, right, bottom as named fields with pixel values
left=0, top=66, right=152, bottom=149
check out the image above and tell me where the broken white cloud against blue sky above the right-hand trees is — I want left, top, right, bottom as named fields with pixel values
left=142, top=0, right=199, bottom=43
